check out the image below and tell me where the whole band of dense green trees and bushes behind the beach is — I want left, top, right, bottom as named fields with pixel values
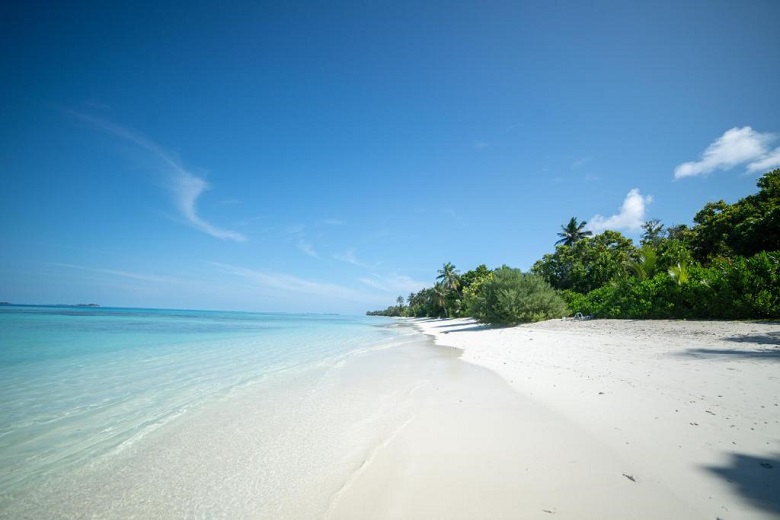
left=369, top=169, right=780, bottom=324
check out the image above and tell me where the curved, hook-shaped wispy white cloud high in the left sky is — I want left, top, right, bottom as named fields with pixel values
left=67, top=110, right=246, bottom=242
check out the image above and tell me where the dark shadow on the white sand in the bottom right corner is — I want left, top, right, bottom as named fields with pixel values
left=705, top=453, right=780, bottom=518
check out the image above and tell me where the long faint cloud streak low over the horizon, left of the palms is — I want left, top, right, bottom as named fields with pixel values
left=211, top=262, right=373, bottom=302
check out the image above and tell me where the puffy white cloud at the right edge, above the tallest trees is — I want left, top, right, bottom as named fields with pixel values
left=674, top=126, right=780, bottom=179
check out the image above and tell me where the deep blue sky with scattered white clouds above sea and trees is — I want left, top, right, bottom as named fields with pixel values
left=0, top=0, right=780, bottom=313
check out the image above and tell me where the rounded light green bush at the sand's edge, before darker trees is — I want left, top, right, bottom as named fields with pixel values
left=472, top=267, right=568, bottom=325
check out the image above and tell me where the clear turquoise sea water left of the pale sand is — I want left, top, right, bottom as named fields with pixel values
left=0, top=306, right=409, bottom=496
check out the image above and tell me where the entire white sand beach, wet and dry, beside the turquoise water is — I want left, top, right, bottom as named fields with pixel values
left=0, top=319, right=780, bottom=520
